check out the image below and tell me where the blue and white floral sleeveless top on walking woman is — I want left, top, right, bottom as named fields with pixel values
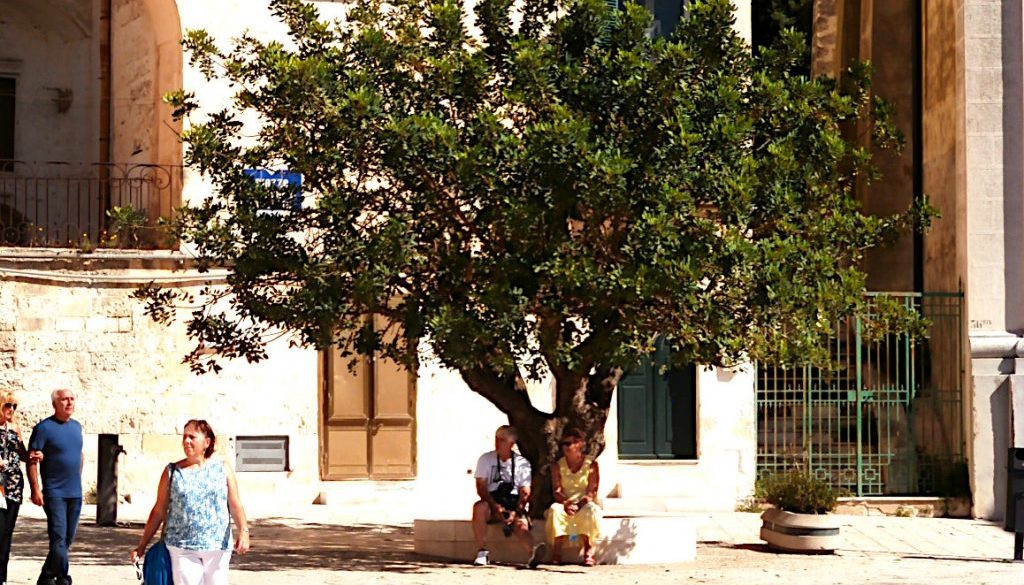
left=164, top=460, right=231, bottom=550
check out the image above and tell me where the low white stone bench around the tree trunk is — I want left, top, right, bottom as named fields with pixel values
left=413, top=514, right=698, bottom=565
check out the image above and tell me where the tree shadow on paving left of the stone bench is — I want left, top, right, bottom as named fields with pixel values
left=11, top=518, right=450, bottom=573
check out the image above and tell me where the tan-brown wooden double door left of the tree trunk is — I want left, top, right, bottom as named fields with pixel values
left=321, top=349, right=416, bottom=479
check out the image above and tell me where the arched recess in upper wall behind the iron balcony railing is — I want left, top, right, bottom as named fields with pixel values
left=0, top=0, right=182, bottom=249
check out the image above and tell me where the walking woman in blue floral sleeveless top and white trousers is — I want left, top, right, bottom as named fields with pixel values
left=131, top=419, right=249, bottom=585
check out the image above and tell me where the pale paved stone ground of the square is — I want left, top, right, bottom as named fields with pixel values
left=8, top=504, right=1024, bottom=585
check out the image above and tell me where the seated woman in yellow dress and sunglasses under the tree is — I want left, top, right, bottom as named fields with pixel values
left=547, top=427, right=601, bottom=567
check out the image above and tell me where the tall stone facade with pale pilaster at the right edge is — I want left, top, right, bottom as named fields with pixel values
left=813, top=0, right=1024, bottom=519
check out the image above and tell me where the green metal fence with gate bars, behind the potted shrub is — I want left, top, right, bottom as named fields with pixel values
left=757, top=293, right=967, bottom=496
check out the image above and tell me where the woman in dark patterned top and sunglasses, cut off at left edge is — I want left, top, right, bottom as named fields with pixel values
left=0, top=390, right=27, bottom=585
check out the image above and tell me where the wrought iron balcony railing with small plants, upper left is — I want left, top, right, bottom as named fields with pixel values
left=0, top=160, right=182, bottom=249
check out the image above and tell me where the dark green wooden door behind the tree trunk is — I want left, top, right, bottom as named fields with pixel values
left=617, top=341, right=697, bottom=459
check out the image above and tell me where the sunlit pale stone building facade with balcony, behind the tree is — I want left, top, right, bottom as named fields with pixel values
left=0, top=0, right=756, bottom=522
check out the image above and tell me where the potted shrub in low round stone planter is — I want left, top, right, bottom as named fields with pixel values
left=760, top=470, right=839, bottom=552
